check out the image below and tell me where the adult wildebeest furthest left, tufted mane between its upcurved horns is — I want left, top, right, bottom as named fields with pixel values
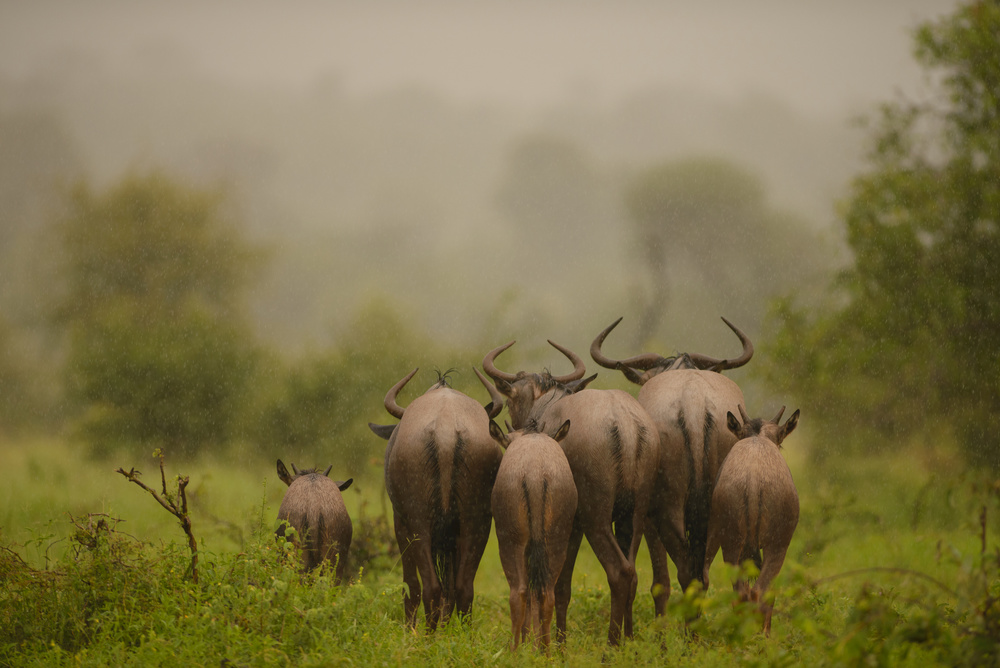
left=369, top=369, right=503, bottom=631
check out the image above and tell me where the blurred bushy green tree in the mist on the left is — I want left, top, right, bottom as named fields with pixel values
left=55, top=173, right=261, bottom=455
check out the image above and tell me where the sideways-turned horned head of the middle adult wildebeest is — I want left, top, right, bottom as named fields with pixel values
left=483, top=340, right=597, bottom=429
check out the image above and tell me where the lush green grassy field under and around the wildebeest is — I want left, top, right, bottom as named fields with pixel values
left=0, top=434, right=1000, bottom=666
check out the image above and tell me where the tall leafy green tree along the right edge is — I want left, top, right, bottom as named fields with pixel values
left=761, top=1, right=1000, bottom=473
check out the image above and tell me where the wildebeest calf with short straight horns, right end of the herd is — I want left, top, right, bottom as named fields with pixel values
left=704, top=406, right=799, bottom=634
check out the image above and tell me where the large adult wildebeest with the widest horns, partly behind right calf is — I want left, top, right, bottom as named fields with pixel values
left=590, top=318, right=753, bottom=615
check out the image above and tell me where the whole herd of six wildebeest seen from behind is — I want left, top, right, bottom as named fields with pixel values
left=277, top=318, right=799, bottom=651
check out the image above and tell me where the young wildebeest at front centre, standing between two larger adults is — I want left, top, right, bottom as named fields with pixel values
left=490, top=420, right=577, bottom=653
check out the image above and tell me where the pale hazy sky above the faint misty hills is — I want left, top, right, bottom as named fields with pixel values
left=0, top=0, right=955, bottom=116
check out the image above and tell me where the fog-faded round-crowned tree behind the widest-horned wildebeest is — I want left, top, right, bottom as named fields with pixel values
left=625, top=158, right=828, bottom=347
